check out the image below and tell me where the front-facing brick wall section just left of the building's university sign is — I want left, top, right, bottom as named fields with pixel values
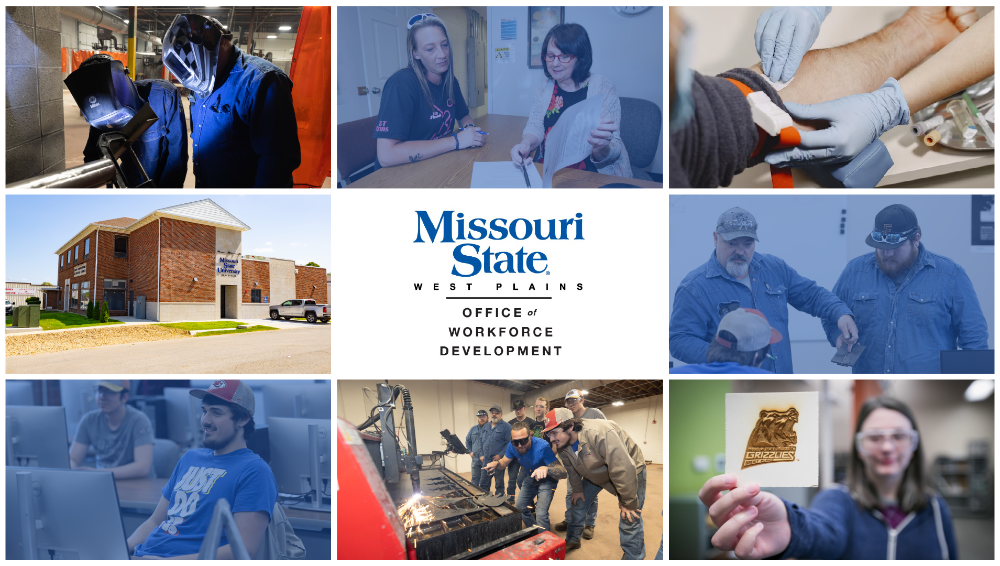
left=160, top=218, right=215, bottom=303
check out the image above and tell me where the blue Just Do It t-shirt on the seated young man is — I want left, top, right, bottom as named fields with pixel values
left=135, top=448, right=278, bottom=557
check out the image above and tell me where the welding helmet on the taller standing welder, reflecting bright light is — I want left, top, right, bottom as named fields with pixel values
left=163, top=14, right=233, bottom=97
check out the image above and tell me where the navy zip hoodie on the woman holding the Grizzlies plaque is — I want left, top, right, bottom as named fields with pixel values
left=774, top=486, right=958, bottom=560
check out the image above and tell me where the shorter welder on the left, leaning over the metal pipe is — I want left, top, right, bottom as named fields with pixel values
left=63, top=53, right=188, bottom=188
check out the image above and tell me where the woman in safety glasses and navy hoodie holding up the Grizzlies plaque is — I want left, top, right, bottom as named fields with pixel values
left=698, top=397, right=958, bottom=560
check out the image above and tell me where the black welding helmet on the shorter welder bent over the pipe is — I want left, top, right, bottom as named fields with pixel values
left=63, top=53, right=145, bottom=132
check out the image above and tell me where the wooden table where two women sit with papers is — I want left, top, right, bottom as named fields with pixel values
left=347, top=114, right=663, bottom=189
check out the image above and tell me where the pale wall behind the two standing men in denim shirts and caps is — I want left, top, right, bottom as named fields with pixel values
left=668, top=195, right=996, bottom=373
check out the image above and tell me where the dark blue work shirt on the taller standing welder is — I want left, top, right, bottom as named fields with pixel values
left=191, top=47, right=301, bottom=188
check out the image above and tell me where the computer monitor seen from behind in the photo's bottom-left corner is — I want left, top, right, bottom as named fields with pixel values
left=6, top=466, right=129, bottom=560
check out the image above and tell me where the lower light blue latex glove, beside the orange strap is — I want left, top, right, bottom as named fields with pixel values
left=764, top=79, right=910, bottom=167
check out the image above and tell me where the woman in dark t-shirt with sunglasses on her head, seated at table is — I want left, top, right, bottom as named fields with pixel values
left=372, top=14, right=485, bottom=171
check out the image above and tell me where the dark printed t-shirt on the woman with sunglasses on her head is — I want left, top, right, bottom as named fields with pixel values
left=372, top=67, right=469, bottom=170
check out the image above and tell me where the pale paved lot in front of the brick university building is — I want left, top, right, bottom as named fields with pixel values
left=6, top=326, right=333, bottom=375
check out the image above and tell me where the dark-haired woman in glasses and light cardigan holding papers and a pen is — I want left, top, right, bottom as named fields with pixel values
left=510, top=24, right=632, bottom=177
